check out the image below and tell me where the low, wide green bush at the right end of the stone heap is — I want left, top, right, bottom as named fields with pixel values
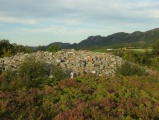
left=117, top=61, right=146, bottom=76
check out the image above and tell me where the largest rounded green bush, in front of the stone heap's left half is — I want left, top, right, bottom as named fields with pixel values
left=18, top=56, right=46, bottom=80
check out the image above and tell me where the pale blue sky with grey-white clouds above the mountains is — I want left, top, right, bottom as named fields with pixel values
left=0, top=0, right=159, bottom=46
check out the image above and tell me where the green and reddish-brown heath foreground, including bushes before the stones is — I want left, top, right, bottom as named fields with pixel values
left=0, top=57, right=159, bottom=120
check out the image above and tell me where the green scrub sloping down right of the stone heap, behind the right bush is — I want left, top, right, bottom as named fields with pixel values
left=113, top=41, right=159, bottom=71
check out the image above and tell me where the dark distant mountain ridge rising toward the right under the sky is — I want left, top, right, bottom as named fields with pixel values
left=47, top=28, right=159, bottom=48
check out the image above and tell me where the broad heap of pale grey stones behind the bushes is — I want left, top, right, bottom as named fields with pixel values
left=0, top=49, right=122, bottom=78
